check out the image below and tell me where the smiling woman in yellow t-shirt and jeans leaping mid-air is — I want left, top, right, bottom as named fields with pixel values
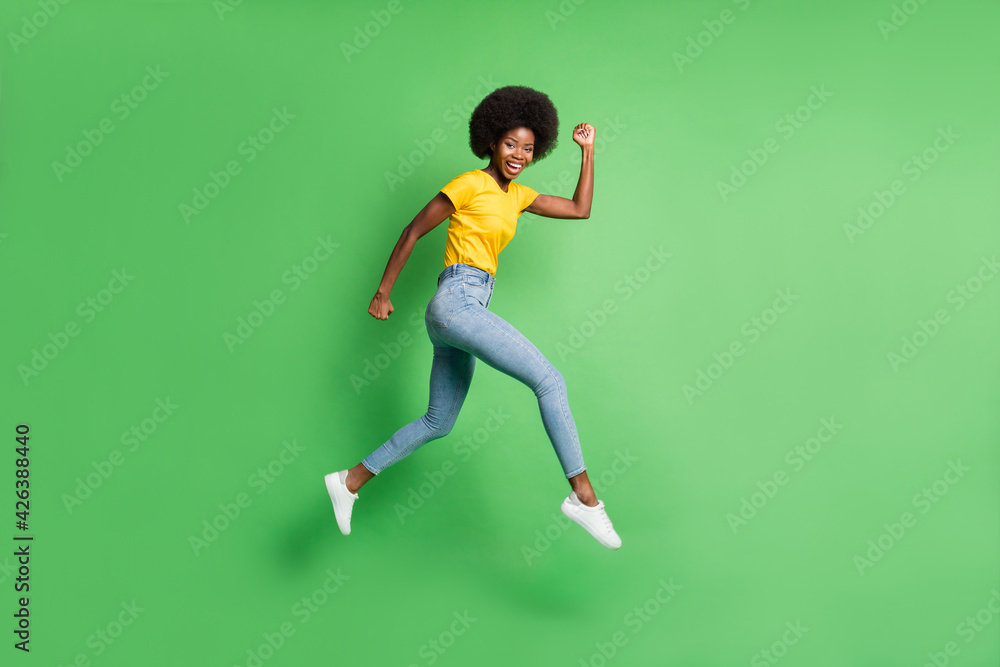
left=326, top=86, right=621, bottom=549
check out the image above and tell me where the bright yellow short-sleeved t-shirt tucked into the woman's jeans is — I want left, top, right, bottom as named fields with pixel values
left=441, top=169, right=538, bottom=276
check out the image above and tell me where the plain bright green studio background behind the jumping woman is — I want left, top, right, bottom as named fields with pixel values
left=0, top=0, right=1000, bottom=667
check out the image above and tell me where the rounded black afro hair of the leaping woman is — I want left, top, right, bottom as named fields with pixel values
left=469, top=86, right=559, bottom=162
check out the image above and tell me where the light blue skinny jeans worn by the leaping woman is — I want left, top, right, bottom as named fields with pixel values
left=361, top=264, right=587, bottom=478
